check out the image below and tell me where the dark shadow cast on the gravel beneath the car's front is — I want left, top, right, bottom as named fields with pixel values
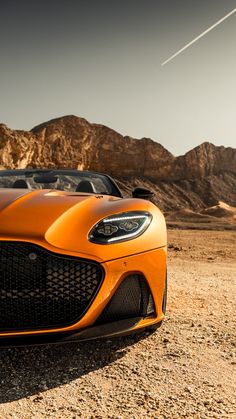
left=0, top=332, right=147, bottom=403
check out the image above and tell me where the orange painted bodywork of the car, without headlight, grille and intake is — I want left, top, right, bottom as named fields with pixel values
left=0, top=189, right=167, bottom=336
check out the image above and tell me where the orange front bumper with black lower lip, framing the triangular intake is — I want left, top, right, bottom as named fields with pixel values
left=0, top=247, right=166, bottom=346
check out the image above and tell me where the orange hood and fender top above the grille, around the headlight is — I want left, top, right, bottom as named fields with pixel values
left=0, top=189, right=166, bottom=260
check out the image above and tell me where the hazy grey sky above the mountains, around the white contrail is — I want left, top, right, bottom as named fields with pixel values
left=0, top=0, right=236, bottom=155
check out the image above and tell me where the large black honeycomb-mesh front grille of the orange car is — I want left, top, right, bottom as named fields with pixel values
left=0, top=242, right=103, bottom=331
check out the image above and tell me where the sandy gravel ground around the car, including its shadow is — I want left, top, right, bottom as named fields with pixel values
left=0, top=230, right=236, bottom=419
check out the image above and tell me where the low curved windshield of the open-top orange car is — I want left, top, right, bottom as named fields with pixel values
left=0, top=169, right=121, bottom=197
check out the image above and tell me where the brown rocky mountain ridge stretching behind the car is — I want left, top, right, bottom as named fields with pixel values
left=0, top=116, right=236, bottom=210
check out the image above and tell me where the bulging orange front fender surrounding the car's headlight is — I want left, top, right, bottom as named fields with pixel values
left=45, top=197, right=167, bottom=261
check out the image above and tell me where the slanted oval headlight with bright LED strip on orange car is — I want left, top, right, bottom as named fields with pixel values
left=89, top=211, right=152, bottom=244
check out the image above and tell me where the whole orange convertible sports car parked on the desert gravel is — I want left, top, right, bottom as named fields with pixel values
left=0, top=169, right=167, bottom=345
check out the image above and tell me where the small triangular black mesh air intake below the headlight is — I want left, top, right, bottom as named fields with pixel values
left=96, top=274, right=155, bottom=324
